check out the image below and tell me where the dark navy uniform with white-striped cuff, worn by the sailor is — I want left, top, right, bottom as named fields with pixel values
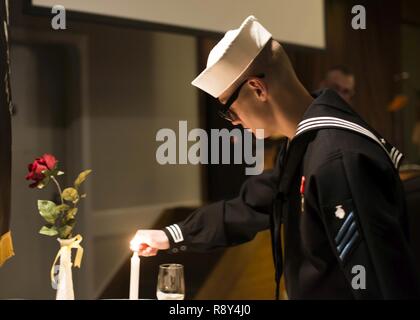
left=164, top=89, right=420, bottom=299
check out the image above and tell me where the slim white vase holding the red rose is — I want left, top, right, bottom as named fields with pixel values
left=56, top=239, right=74, bottom=300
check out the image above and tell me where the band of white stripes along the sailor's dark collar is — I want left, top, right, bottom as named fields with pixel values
left=295, top=117, right=402, bottom=169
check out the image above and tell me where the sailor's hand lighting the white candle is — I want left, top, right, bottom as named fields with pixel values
left=131, top=230, right=169, bottom=257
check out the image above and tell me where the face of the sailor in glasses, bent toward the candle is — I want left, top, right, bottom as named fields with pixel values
left=219, top=77, right=274, bottom=139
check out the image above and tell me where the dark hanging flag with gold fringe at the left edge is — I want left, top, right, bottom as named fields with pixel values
left=0, top=0, right=14, bottom=266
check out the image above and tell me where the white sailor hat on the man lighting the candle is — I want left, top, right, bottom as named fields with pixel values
left=191, top=16, right=272, bottom=98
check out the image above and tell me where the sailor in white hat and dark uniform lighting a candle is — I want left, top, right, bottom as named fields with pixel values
left=136, top=16, right=420, bottom=299
